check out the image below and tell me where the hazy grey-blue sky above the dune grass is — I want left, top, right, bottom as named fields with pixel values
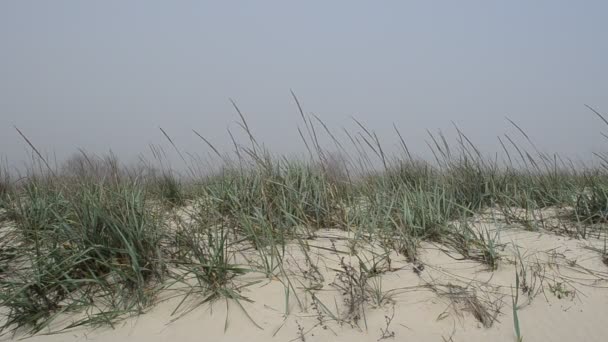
left=0, top=0, right=608, bottom=168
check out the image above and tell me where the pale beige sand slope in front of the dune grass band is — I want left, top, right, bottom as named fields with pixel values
left=4, top=214, right=608, bottom=342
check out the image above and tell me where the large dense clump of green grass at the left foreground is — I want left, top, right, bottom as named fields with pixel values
left=0, top=181, right=166, bottom=332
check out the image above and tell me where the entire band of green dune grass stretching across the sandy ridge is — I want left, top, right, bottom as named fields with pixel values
left=0, top=104, right=608, bottom=335
